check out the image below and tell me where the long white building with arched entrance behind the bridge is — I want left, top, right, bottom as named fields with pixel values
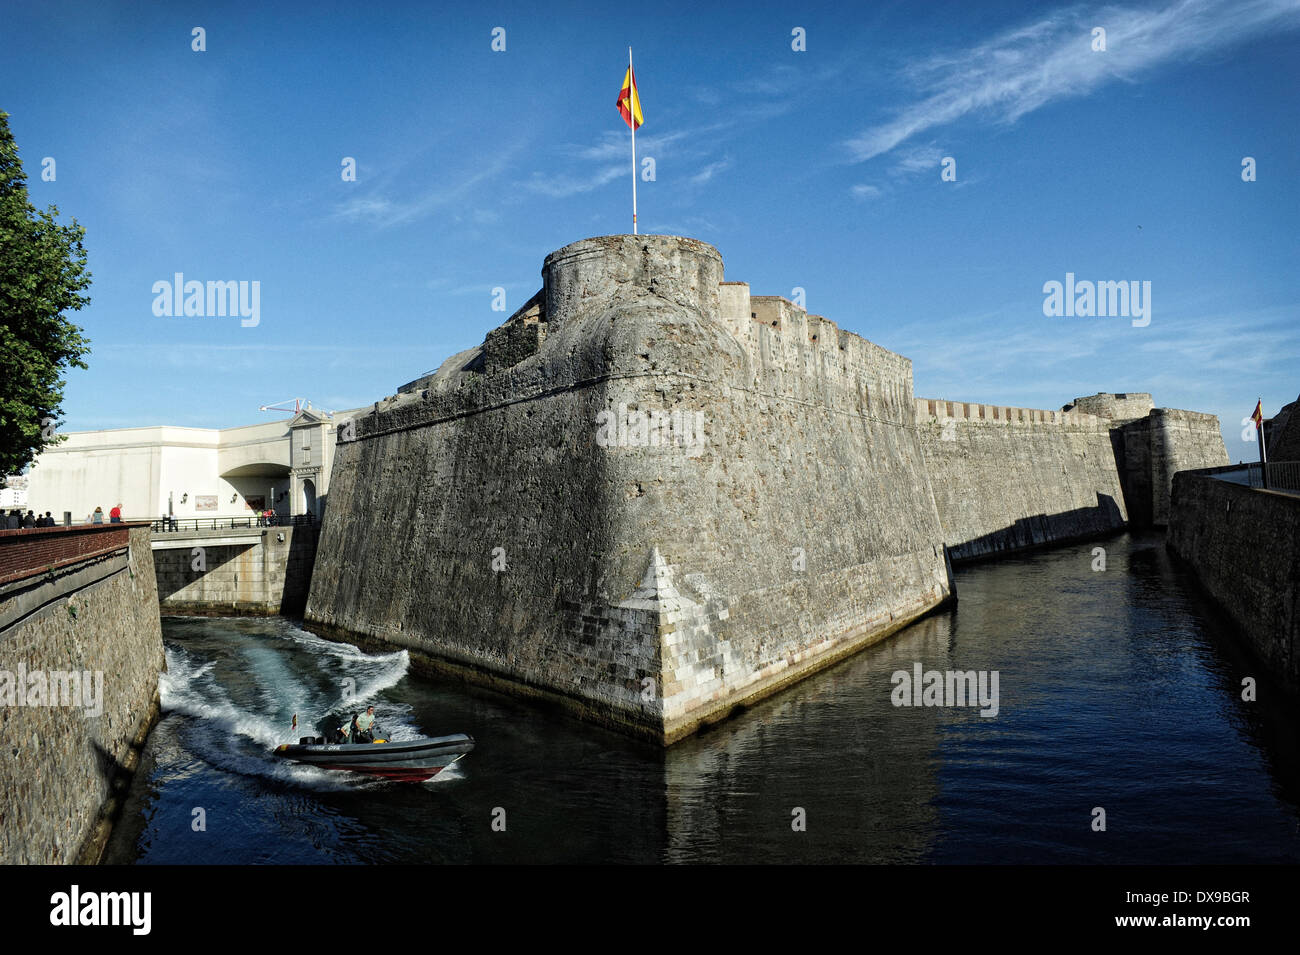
left=26, top=408, right=351, bottom=522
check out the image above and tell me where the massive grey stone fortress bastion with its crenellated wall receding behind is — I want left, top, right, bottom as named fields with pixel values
left=306, top=235, right=1222, bottom=743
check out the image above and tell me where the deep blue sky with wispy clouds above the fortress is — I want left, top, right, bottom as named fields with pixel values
left=0, top=0, right=1300, bottom=460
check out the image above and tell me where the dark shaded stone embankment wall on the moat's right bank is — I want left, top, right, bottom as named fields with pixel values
left=1167, top=472, right=1300, bottom=693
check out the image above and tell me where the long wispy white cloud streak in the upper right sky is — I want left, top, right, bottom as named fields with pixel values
left=845, top=0, right=1300, bottom=161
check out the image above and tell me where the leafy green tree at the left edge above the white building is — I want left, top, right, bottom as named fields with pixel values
left=0, top=110, right=90, bottom=482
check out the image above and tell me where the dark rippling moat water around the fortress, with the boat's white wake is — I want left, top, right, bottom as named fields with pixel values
left=108, top=535, right=1300, bottom=863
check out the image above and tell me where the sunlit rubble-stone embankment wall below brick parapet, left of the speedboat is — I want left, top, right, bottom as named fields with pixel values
left=0, top=526, right=165, bottom=864
